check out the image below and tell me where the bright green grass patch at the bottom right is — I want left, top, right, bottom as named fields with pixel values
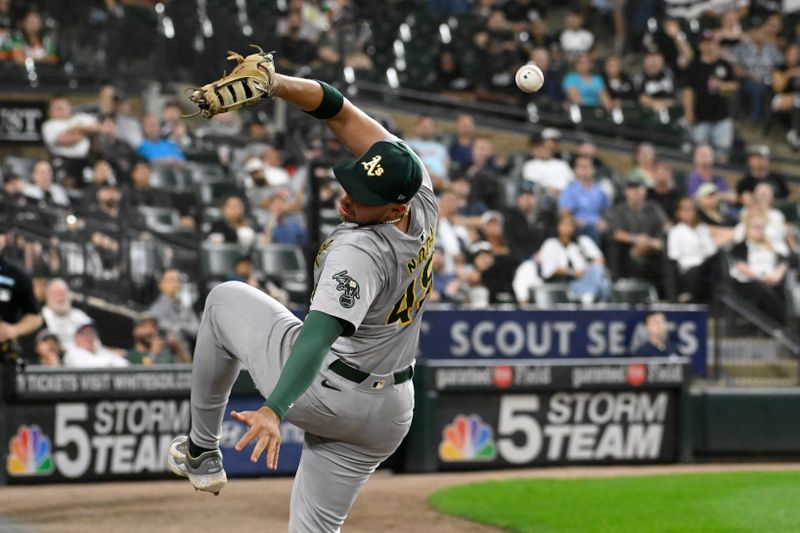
left=430, top=472, right=800, bottom=533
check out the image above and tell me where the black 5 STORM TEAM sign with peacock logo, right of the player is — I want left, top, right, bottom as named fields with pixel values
left=435, top=391, right=678, bottom=470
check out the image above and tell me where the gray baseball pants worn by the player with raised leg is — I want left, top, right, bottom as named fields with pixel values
left=191, top=282, right=414, bottom=533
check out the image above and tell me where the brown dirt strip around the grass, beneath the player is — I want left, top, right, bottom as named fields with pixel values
left=0, top=463, right=800, bottom=533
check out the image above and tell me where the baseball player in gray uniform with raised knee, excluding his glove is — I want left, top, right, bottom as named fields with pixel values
left=169, top=67, right=437, bottom=533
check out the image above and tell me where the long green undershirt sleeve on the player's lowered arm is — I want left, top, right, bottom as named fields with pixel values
left=264, top=311, right=344, bottom=420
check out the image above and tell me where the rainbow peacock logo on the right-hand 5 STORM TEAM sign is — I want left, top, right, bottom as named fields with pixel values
left=439, top=414, right=497, bottom=462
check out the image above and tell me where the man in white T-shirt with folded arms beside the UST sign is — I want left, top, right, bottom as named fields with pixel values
left=42, top=96, right=100, bottom=187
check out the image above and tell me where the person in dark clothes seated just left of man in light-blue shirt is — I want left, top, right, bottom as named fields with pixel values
left=505, top=181, right=555, bottom=263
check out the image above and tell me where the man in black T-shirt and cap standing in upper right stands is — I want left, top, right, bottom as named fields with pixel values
left=683, top=30, right=739, bottom=160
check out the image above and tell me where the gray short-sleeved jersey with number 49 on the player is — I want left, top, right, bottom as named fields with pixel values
left=311, top=153, right=438, bottom=374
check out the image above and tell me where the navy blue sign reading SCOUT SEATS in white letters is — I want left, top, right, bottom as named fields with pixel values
left=419, top=309, right=708, bottom=376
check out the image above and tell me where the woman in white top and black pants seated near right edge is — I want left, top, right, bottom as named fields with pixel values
left=730, top=216, right=788, bottom=324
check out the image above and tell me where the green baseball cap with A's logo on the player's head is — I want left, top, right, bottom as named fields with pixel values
left=333, top=141, right=422, bottom=206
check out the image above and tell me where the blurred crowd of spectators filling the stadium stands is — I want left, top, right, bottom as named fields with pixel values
left=0, top=0, right=800, bottom=366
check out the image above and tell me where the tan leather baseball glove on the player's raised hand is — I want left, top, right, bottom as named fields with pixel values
left=186, top=44, right=275, bottom=118
